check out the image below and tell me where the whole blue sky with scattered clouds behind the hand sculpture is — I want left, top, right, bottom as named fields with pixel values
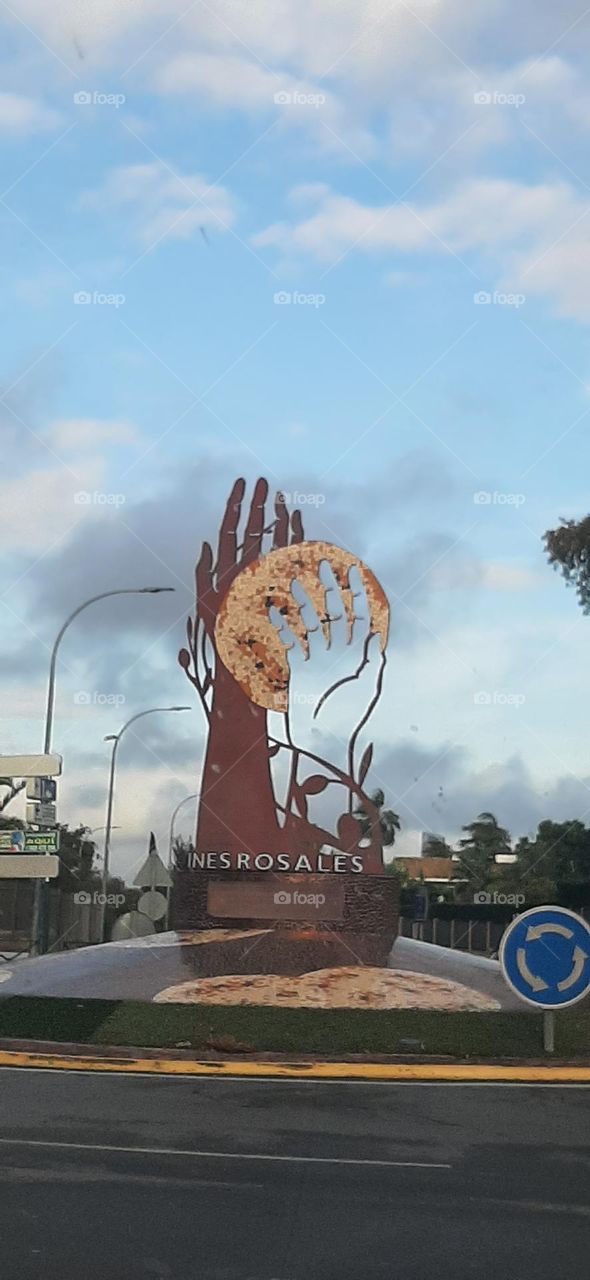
left=0, top=0, right=590, bottom=870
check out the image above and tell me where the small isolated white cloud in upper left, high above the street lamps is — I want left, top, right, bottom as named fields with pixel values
left=79, top=161, right=235, bottom=246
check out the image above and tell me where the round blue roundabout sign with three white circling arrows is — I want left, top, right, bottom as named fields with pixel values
left=499, top=906, right=590, bottom=1010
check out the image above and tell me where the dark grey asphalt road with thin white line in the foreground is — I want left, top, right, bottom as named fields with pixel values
left=0, top=1069, right=590, bottom=1280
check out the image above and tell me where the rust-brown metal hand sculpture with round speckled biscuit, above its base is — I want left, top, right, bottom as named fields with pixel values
left=179, top=480, right=389, bottom=874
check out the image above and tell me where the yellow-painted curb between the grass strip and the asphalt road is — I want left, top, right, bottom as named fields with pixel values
left=0, top=1051, right=590, bottom=1084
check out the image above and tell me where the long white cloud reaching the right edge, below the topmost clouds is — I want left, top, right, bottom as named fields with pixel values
left=252, top=178, right=590, bottom=321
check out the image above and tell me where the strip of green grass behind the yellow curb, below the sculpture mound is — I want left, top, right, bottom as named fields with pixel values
left=0, top=996, right=590, bottom=1059
